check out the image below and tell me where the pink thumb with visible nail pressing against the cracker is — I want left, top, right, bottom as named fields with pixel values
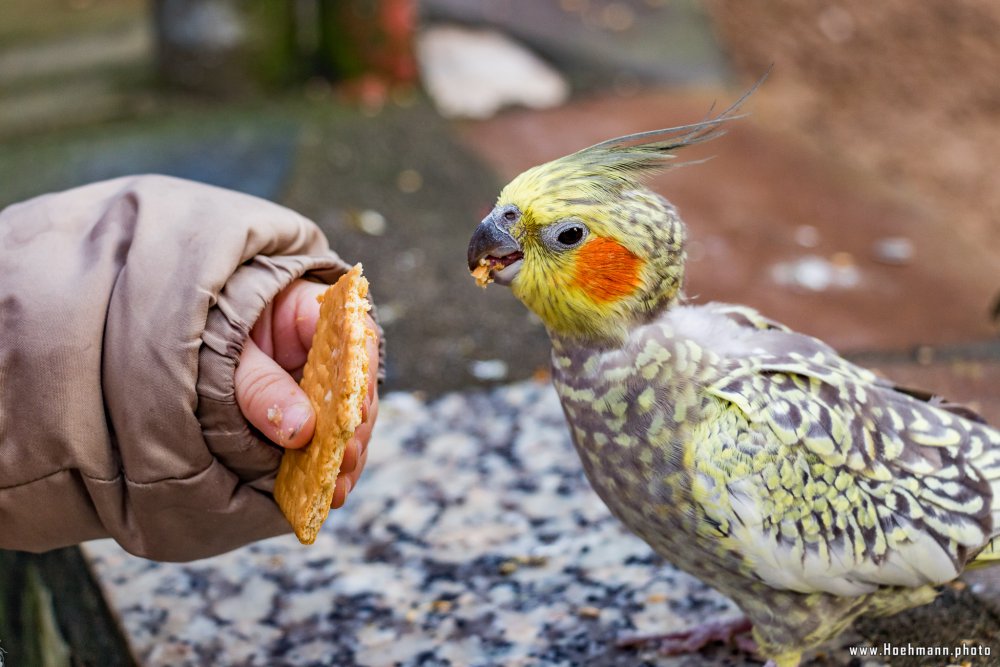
left=235, top=339, right=316, bottom=449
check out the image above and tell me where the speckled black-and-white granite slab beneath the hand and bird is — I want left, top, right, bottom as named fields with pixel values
left=86, top=382, right=860, bottom=667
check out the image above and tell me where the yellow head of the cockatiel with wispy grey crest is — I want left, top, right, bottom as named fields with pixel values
left=468, top=92, right=756, bottom=348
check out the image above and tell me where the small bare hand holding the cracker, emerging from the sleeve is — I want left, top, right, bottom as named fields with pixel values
left=236, top=280, right=378, bottom=509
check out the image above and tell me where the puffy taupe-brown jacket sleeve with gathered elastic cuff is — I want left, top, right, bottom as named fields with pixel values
left=0, top=176, right=356, bottom=560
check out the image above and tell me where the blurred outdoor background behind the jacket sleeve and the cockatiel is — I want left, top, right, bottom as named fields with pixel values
left=0, top=0, right=1000, bottom=664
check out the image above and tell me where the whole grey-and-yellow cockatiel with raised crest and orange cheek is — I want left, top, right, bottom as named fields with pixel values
left=468, top=91, right=1000, bottom=667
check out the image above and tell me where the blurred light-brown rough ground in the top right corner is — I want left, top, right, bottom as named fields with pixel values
left=705, top=0, right=1000, bottom=268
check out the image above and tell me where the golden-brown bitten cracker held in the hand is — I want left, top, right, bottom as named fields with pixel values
left=274, top=264, right=374, bottom=544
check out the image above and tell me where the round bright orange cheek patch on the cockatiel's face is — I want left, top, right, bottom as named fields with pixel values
left=573, top=236, right=642, bottom=303
